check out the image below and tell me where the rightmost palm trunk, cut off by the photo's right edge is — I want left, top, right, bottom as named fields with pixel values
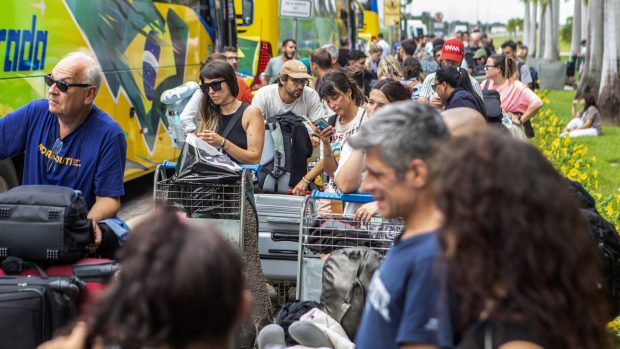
left=598, top=0, right=620, bottom=124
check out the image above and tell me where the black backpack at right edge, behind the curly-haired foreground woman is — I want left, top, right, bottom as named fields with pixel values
left=566, top=179, right=620, bottom=317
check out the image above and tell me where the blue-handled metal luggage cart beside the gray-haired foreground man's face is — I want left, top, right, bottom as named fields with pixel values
left=297, top=190, right=404, bottom=302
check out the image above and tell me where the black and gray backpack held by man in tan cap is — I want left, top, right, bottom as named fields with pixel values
left=257, top=112, right=312, bottom=194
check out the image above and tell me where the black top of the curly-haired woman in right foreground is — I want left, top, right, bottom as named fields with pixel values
left=455, top=319, right=545, bottom=349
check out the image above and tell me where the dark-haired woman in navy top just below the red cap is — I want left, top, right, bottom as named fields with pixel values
left=432, top=66, right=485, bottom=115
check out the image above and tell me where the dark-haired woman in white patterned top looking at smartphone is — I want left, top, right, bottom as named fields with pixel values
left=293, top=71, right=366, bottom=208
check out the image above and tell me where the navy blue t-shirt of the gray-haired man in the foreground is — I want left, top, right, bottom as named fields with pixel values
left=355, top=232, right=453, bottom=349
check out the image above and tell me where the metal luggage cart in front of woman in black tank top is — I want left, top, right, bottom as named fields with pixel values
left=153, top=161, right=260, bottom=249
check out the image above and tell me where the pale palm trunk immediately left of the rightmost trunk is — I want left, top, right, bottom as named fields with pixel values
left=577, top=0, right=604, bottom=97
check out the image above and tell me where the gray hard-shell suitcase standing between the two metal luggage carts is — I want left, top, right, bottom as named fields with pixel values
left=254, top=194, right=304, bottom=281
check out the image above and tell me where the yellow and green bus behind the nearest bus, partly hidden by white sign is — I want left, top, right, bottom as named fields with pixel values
left=235, top=0, right=349, bottom=85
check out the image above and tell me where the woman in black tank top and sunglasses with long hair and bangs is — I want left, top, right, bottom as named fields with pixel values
left=196, top=61, right=265, bottom=164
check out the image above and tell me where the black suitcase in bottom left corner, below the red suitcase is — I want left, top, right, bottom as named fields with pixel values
left=0, top=276, right=84, bottom=349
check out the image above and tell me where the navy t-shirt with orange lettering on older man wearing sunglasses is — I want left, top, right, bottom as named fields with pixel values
left=0, top=99, right=127, bottom=209
